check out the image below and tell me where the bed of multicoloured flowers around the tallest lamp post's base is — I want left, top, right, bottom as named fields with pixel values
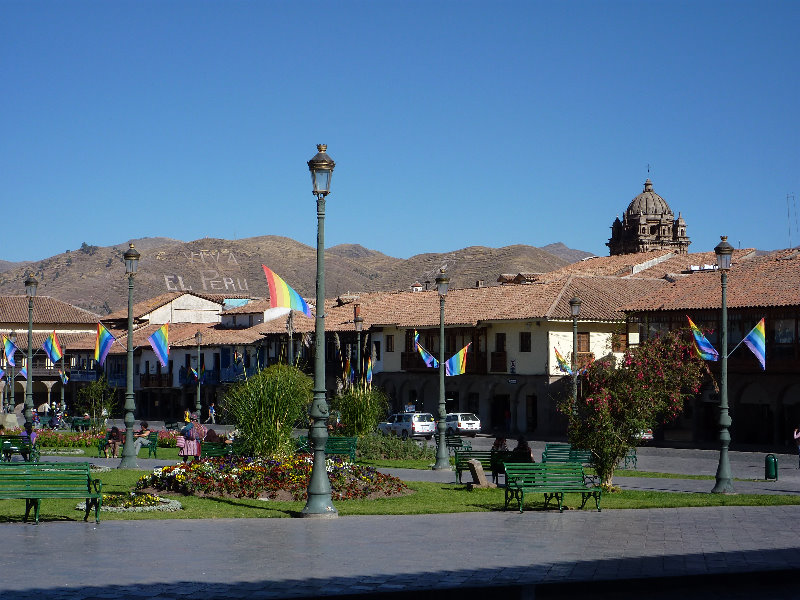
left=136, top=454, right=407, bottom=500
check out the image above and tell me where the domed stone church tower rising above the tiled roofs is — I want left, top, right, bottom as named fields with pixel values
left=606, top=179, right=691, bottom=256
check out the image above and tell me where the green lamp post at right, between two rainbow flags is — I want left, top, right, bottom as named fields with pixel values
left=711, top=235, right=734, bottom=494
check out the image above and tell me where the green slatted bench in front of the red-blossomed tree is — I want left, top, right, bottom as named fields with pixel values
left=505, top=462, right=602, bottom=512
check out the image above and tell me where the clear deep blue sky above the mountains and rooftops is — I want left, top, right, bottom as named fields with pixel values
left=0, top=0, right=800, bottom=261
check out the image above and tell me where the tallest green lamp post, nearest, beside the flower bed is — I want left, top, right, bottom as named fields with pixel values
left=300, top=144, right=339, bottom=518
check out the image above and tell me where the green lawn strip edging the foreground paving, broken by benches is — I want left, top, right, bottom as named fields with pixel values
left=0, top=470, right=800, bottom=523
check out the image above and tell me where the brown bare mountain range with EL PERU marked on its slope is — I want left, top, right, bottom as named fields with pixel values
left=0, top=235, right=589, bottom=314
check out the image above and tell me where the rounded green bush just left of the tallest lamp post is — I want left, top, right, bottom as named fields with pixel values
left=221, top=364, right=313, bottom=456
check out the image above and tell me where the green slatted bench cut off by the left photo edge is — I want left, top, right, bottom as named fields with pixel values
left=0, top=462, right=103, bottom=523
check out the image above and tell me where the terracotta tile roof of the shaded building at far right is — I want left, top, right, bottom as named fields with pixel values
left=623, top=250, right=800, bottom=312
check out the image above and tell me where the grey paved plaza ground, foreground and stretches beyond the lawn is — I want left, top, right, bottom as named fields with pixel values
left=0, top=438, right=800, bottom=600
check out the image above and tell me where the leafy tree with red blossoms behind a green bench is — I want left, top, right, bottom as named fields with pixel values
left=559, top=329, right=706, bottom=488
